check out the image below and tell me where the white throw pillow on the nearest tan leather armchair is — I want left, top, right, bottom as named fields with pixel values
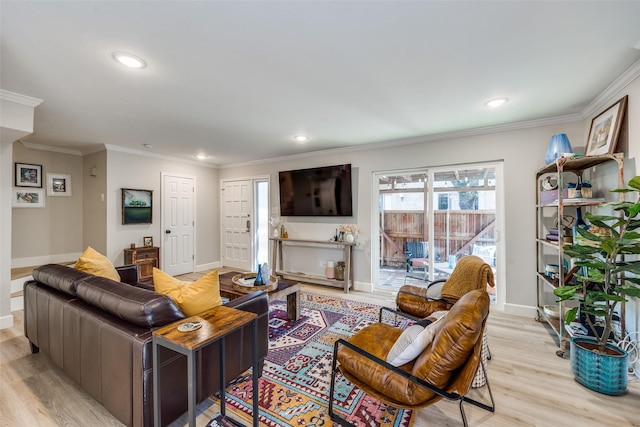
left=387, top=311, right=447, bottom=366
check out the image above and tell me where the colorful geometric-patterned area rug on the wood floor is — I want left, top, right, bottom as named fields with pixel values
left=214, top=292, right=412, bottom=427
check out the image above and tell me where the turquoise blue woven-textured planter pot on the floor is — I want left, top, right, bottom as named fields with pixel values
left=571, top=337, right=629, bottom=396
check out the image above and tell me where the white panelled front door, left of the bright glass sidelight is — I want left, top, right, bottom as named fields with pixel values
left=220, top=180, right=253, bottom=271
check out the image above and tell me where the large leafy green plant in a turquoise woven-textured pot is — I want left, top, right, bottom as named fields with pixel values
left=554, top=176, right=640, bottom=395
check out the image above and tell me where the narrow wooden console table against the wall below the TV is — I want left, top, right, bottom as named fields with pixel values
left=269, top=237, right=356, bottom=293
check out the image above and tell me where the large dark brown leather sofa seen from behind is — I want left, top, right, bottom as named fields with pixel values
left=24, top=264, right=269, bottom=427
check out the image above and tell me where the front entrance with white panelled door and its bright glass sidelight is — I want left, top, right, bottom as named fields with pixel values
left=220, top=177, right=269, bottom=271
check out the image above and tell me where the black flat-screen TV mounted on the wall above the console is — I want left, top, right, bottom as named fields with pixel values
left=279, top=164, right=353, bottom=216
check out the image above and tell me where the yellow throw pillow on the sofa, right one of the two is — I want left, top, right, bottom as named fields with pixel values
left=153, top=267, right=222, bottom=316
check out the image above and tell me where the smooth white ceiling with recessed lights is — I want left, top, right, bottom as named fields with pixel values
left=0, top=0, right=640, bottom=165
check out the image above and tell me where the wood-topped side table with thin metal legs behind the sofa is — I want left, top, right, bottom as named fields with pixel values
left=153, top=305, right=259, bottom=427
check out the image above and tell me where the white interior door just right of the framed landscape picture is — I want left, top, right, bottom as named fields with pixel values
left=161, top=174, right=195, bottom=276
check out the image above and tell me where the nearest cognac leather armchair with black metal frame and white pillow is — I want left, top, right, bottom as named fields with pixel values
left=329, top=289, right=495, bottom=426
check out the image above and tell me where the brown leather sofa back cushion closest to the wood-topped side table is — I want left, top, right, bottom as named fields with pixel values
left=77, top=276, right=185, bottom=328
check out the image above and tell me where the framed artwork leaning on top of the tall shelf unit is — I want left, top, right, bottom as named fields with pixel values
left=584, top=96, right=628, bottom=156
